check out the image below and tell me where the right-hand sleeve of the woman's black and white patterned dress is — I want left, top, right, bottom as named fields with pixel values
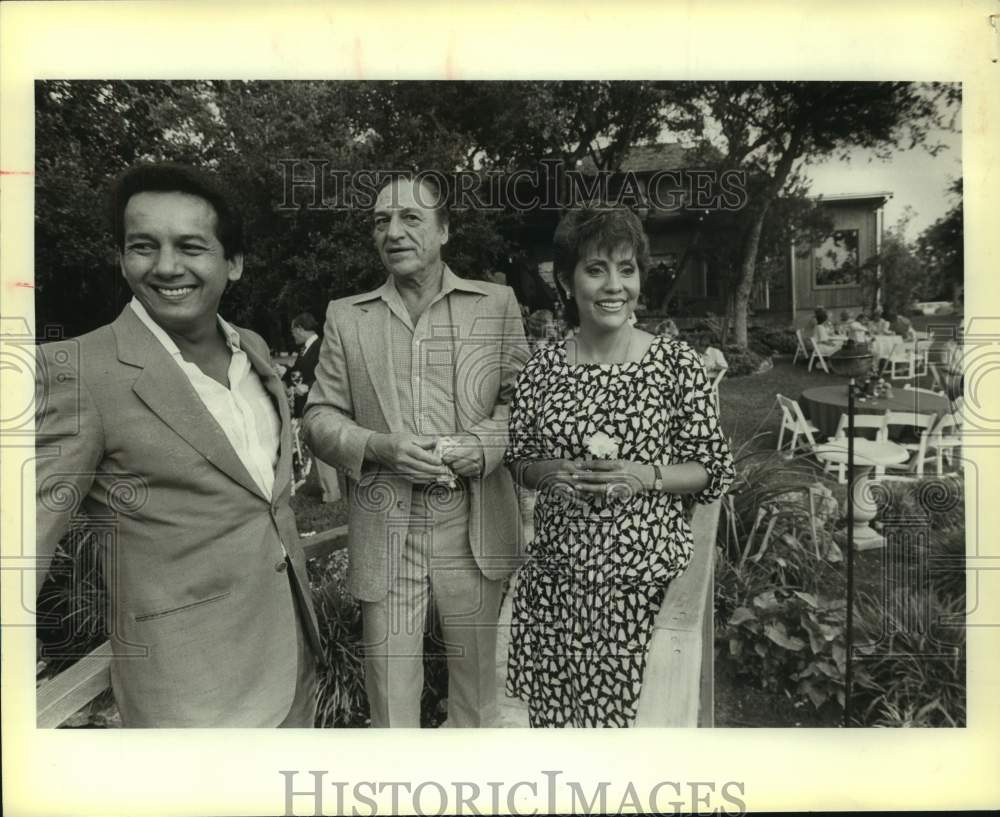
left=670, top=344, right=736, bottom=503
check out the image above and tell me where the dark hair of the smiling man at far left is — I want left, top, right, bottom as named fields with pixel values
left=111, top=162, right=243, bottom=260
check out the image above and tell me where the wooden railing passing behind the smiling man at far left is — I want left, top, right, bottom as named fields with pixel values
left=35, top=525, right=347, bottom=729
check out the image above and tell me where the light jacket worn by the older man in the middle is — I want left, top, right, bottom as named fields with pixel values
left=304, top=272, right=528, bottom=601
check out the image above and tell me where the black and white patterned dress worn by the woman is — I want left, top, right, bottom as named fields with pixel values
left=505, top=337, right=734, bottom=726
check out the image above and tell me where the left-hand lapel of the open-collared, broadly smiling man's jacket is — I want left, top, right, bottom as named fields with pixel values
left=112, top=307, right=265, bottom=498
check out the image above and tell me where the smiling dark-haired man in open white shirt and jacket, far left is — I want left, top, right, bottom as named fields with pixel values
left=36, top=164, right=320, bottom=727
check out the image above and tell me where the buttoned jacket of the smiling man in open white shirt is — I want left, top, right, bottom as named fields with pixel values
left=36, top=306, right=321, bottom=727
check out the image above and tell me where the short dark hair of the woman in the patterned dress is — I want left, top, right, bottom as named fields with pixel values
left=552, top=207, right=650, bottom=326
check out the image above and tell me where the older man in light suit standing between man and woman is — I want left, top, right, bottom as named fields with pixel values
left=305, top=176, right=527, bottom=727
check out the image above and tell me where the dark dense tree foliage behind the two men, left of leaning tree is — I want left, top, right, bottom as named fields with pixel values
left=35, top=81, right=704, bottom=345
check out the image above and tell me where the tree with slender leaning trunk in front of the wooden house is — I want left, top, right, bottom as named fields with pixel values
left=684, top=82, right=959, bottom=348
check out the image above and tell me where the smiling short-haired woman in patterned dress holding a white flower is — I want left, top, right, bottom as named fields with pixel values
left=506, top=209, right=733, bottom=727
